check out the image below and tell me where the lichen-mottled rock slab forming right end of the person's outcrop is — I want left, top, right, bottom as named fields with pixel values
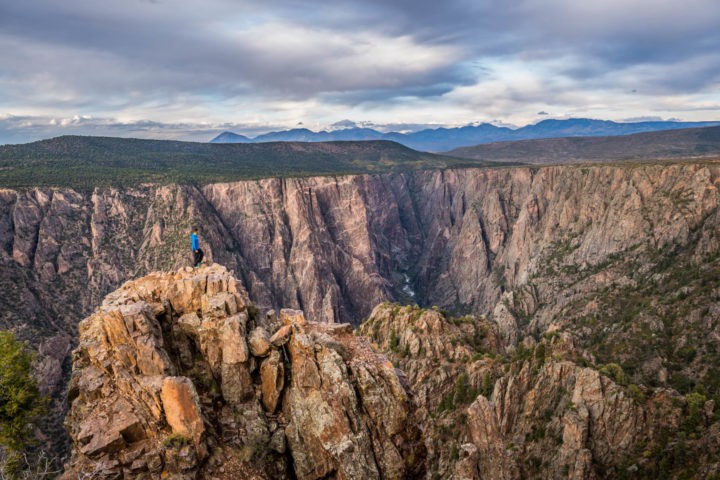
left=283, top=323, right=424, bottom=480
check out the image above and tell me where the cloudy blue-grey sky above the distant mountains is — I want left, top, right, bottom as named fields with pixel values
left=0, top=0, right=720, bottom=144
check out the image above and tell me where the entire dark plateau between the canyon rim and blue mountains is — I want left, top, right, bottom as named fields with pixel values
left=0, top=127, right=720, bottom=189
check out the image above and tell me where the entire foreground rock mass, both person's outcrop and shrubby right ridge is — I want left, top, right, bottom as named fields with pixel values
left=64, top=265, right=720, bottom=480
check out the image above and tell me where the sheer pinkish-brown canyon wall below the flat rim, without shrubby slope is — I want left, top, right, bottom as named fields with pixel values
left=0, top=163, right=720, bottom=331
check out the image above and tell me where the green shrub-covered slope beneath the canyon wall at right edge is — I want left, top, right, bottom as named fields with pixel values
left=536, top=219, right=720, bottom=401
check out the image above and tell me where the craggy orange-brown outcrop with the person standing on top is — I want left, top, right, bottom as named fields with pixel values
left=64, top=265, right=425, bottom=480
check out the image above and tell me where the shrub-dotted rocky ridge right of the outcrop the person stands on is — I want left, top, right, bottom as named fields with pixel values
left=358, top=303, right=720, bottom=480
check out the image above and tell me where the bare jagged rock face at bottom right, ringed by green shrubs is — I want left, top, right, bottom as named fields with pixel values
left=467, top=362, right=648, bottom=479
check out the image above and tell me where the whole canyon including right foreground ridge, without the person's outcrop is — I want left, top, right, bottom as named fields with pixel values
left=0, top=160, right=720, bottom=478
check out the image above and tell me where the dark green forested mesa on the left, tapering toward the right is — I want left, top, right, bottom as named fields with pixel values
left=0, top=136, right=509, bottom=189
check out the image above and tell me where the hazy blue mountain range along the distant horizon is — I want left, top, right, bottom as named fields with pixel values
left=210, top=118, right=720, bottom=152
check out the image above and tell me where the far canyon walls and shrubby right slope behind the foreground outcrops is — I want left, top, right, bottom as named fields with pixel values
left=0, top=161, right=720, bottom=464
